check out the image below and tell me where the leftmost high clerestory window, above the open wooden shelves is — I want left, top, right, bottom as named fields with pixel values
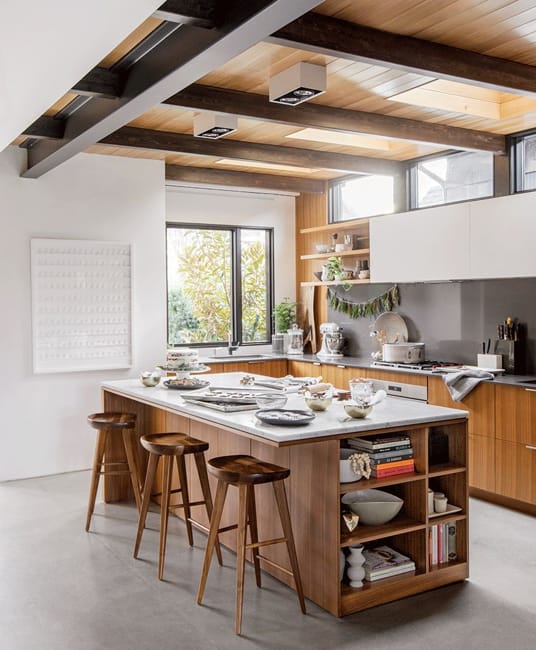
left=328, top=174, right=395, bottom=223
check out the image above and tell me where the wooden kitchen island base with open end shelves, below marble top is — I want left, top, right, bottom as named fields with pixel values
left=103, top=388, right=468, bottom=616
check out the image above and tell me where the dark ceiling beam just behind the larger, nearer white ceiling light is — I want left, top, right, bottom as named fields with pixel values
left=164, top=84, right=506, bottom=154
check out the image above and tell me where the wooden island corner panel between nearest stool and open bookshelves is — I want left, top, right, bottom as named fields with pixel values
left=290, top=440, right=340, bottom=616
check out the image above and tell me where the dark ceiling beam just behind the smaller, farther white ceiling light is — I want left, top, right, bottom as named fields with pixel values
left=101, top=126, right=402, bottom=174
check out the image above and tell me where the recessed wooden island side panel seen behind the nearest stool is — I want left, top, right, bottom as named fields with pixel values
left=251, top=440, right=294, bottom=576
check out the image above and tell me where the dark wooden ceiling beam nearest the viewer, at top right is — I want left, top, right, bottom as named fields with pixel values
left=268, top=12, right=536, bottom=96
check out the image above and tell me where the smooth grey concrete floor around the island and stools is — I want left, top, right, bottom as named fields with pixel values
left=0, top=472, right=536, bottom=650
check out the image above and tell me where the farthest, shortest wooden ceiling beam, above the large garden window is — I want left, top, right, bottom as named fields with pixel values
left=166, top=165, right=326, bottom=194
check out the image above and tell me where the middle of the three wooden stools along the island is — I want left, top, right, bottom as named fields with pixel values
left=134, top=433, right=222, bottom=580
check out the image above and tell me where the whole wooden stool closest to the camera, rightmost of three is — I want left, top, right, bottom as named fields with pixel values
left=197, top=455, right=305, bottom=634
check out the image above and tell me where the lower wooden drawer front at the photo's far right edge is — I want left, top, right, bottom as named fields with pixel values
left=495, top=440, right=536, bottom=505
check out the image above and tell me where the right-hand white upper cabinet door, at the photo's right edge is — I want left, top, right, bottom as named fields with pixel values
left=468, top=192, right=536, bottom=279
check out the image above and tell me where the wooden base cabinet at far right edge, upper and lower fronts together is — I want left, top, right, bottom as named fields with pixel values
left=495, top=385, right=536, bottom=505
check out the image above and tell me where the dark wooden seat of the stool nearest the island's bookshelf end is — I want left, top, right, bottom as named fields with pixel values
left=208, top=454, right=290, bottom=485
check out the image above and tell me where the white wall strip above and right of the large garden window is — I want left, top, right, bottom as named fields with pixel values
left=166, top=185, right=296, bottom=303
